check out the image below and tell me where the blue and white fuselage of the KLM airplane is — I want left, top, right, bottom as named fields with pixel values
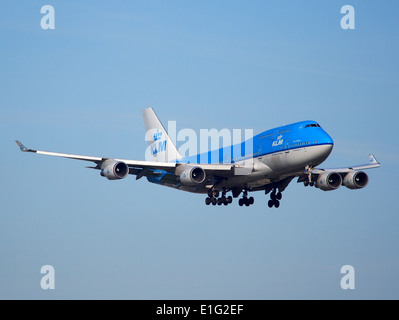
left=147, top=121, right=334, bottom=193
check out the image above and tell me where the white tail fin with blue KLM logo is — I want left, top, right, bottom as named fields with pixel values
left=142, top=108, right=182, bottom=162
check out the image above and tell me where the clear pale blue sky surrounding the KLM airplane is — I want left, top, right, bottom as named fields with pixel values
left=0, top=0, right=399, bottom=299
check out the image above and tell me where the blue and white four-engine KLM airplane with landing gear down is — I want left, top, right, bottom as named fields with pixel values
left=16, top=108, right=380, bottom=208
